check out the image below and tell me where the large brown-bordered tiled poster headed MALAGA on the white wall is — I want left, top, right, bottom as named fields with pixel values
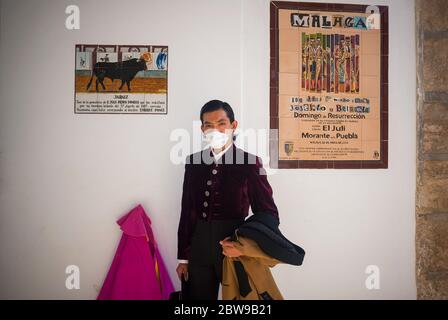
left=270, top=1, right=388, bottom=169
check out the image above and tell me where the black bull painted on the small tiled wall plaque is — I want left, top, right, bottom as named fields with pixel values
left=87, top=58, right=147, bottom=92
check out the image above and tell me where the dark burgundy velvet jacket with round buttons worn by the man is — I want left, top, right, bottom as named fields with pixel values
left=177, top=144, right=278, bottom=259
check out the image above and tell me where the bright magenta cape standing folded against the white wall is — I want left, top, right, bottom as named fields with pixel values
left=97, top=204, right=174, bottom=300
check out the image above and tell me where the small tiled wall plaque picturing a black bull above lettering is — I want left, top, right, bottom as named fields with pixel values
left=75, top=44, right=168, bottom=114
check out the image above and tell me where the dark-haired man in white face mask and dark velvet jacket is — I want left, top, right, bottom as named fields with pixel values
left=176, top=100, right=278, bottom=300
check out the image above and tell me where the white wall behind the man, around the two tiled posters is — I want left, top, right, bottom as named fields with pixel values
left=0, top=0, right=416, bottom=299
